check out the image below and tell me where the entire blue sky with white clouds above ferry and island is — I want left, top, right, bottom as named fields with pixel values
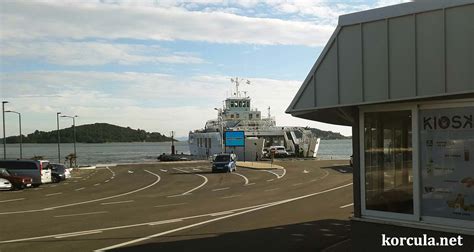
left=0, top=0, right=407, bottom=137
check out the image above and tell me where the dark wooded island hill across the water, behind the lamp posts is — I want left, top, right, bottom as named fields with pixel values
left=2, top=123, right=176, bottom=143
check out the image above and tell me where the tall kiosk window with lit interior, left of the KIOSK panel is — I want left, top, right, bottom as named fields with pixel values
left=364, top=110, right=414, bottom=214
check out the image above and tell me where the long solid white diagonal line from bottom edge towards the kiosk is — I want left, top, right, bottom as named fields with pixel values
left=94, top=183, right=352, bottom=251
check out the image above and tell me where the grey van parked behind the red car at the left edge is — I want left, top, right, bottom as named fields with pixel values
left=0, top=160, right=51, bottom=187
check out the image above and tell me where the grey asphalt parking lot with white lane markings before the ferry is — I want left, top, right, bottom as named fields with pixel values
left=0, top=160, right=353, bottom=252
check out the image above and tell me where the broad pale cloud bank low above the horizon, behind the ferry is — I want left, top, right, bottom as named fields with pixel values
left=0, top=72, right=351, bottom=136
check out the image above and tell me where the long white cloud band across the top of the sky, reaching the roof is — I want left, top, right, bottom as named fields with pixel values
left=1, top=1, right=334, bottom=46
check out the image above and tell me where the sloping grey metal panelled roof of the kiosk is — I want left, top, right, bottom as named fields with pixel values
left=286, top=0, right=474, bottom=125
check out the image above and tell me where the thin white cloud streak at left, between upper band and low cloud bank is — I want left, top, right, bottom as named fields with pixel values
left=0, top=40, right=205, bottom=66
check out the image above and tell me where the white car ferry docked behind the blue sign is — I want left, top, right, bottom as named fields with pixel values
left=188, top=78, right=320, bottom=161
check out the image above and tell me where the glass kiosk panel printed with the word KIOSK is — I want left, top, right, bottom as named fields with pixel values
left=420, top=107, right=474, bottom=220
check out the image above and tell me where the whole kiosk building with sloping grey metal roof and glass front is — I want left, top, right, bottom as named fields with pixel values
left=286, top=0, right=474, bottom=251
